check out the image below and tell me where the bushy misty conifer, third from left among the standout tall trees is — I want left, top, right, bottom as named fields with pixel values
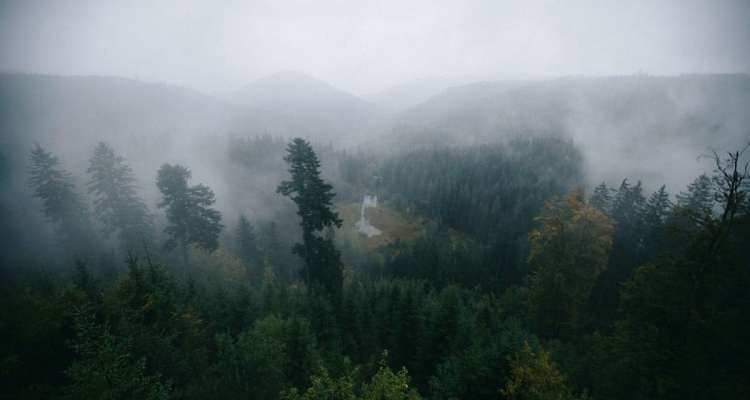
left=156, top=164, right=222, bottom=264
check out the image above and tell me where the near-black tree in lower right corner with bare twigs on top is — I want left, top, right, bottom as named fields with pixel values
left=608, top=152, right=750, bottom=399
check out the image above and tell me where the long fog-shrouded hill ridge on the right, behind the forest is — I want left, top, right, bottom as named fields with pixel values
left=384, top=74, right=750, bottom=190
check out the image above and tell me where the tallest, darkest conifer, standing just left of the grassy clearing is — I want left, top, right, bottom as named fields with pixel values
left=276, top=138, right=343, bottom=292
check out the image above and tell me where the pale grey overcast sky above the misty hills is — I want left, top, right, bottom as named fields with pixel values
left=0, top=0, right=750, bottom=94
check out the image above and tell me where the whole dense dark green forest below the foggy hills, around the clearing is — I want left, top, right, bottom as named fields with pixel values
left=0, top=117, right=750, bottom=399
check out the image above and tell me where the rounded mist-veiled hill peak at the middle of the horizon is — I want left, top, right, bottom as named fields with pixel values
left=230, top=71, right=383, bottom=144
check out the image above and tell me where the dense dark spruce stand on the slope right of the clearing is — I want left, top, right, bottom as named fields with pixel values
left=377, top=138, right=583, bottom=289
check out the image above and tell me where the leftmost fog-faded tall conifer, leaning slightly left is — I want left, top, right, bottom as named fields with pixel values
left=29, top=144, right=94, bottom=255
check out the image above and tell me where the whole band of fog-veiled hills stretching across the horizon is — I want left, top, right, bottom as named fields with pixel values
left=0, top=72, right=750, bottom=192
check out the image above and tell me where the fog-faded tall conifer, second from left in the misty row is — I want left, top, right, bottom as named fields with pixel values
left=87, top=142, right=153, bottom=251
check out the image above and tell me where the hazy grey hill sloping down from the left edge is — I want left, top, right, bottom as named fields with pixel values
left=0, top=74, right=302, bottom=177
